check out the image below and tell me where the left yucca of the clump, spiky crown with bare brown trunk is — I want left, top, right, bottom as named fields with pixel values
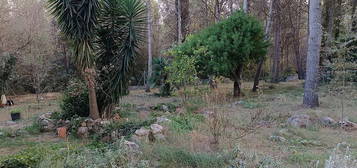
left=49, top=0, right=100, bottom=119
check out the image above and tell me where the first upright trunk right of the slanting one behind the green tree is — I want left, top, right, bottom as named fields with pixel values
left=271, top=0, right=281, bottom=83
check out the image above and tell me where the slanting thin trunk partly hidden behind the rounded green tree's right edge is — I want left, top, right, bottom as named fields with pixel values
left=252, top=0, right=275, bottom=92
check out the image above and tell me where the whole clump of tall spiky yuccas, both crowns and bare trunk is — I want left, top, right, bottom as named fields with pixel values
left=49, top=0, right=146, bottom=119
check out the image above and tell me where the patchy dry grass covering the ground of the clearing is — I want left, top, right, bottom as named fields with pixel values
left=0, top=82, right=357, bottom=168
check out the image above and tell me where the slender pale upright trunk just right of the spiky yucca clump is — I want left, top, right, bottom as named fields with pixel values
left=145, top=0, right=152, bottom=92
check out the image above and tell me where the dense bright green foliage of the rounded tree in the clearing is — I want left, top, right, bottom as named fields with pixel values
left=172, top=11, right=268, bottom=80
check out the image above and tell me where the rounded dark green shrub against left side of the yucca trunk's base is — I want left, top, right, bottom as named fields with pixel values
left=60, top=80, right=89, bottom=120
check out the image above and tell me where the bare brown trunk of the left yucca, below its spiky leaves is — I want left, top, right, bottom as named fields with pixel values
left=84, top=68, right=100, bottom=120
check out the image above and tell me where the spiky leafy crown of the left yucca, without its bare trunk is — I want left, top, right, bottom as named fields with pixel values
left=48, top=0, right=100, bottom=68
